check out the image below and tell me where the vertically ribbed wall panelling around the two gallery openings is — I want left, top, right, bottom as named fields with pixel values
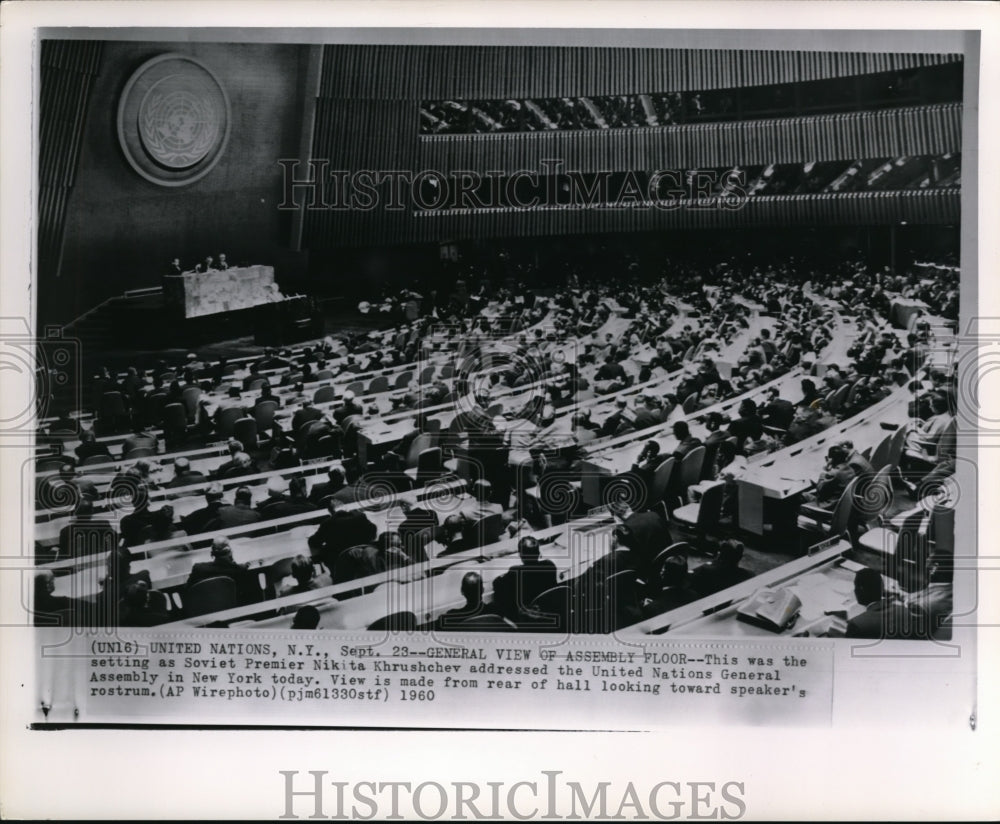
left=302, top=45, right=962, bottom=249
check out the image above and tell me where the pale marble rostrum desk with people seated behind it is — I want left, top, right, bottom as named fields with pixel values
left=163, top=266, right=274, bottom=318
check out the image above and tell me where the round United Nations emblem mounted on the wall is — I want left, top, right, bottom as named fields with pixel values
left=118, top=54, right=231, bottom=186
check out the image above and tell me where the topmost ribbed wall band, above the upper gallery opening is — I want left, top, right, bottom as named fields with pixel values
left=320, top=45, right=956, bottom=100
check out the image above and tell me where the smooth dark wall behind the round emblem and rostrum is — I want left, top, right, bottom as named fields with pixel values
left=46, top=42, right=307, bottom=322
